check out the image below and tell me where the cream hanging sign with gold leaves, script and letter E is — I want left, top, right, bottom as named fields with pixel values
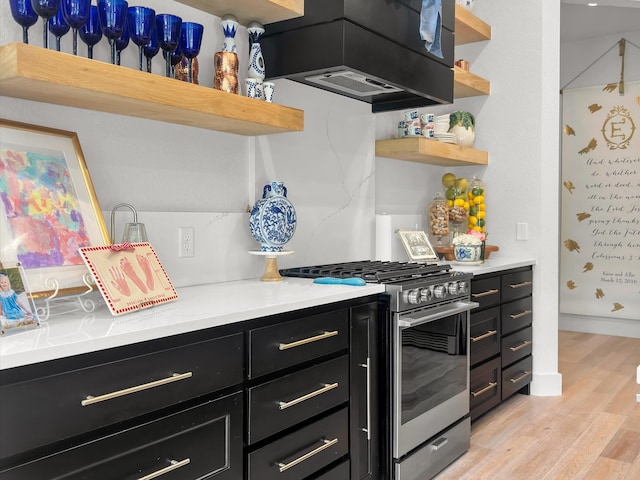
left=560, top=82, right=640, bottom=321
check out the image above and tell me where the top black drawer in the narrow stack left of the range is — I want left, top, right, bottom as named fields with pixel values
left=249, top=309, right=349, bottom=378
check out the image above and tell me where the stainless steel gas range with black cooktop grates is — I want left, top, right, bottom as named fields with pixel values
left=280, top=261, right=477, bottom=480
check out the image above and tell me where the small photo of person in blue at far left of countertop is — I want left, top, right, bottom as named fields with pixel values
left=0, top=262, right=39, bottom=334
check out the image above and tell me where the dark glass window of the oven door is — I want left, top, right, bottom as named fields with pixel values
left=401, top=313, right=468, bottom=424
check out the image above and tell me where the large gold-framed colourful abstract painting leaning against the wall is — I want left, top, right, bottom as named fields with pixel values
left=0, top=119, right=109, bottom=298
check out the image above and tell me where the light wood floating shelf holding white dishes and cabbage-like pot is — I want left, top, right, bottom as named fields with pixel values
left=376, top=137, right=489, bottom=166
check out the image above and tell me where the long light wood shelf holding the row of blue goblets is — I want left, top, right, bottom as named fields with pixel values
left=0, top=43, right=304, bottom=136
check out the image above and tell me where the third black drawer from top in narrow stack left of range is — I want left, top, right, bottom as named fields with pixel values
left=248, top=408, right=349, bottom=480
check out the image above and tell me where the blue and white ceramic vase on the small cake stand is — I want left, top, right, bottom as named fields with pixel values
left=249, top=182, right=297, bottom=252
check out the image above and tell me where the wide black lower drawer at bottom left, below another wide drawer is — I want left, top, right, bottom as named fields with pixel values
left=0, top=392, right=242, bottom=480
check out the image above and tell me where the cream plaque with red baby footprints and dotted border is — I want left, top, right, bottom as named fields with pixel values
left=80, top=243, right=178, bottom=315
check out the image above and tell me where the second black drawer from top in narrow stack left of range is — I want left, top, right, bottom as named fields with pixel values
left=248, top=355, right=349, bottom=443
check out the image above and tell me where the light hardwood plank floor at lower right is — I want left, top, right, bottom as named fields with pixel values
left=436, top=331, right=640, bottom=480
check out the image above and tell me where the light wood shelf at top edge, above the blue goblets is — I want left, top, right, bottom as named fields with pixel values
left=176, top=0, right=304, bottom=26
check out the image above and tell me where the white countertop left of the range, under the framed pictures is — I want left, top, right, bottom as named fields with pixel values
left=0, top=278, right=384, bottom=369
